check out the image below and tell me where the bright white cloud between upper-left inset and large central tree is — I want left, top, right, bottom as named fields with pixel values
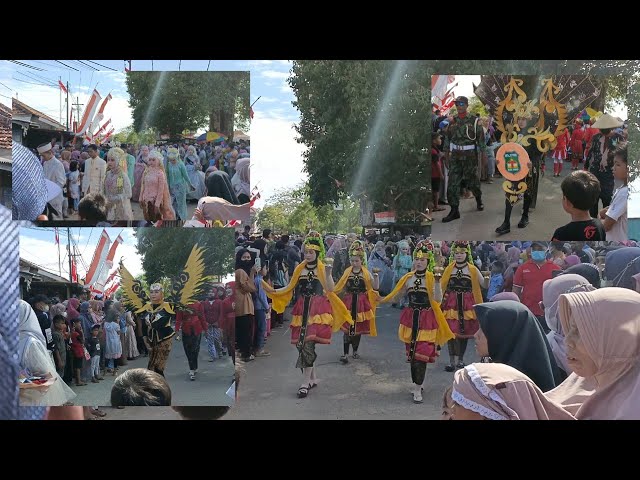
left=250, top=114, right=307, bottom=207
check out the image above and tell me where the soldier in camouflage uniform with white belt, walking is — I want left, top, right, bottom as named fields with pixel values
left=442, top=97, right=487, bottom=223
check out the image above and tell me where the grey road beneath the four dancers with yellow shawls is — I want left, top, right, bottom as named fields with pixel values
left=224, top=305, right=479, bottom=420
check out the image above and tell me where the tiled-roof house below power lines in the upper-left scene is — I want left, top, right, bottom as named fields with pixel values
left=11, top=98, right=73, bottom=148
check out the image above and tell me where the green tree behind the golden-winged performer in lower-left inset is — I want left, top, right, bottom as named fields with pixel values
left=135, top=228, right=235, bottom=283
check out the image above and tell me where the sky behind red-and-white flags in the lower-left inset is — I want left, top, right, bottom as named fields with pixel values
left=20, top=227, right=142, bottom=278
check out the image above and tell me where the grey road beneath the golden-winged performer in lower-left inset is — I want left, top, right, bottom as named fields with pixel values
left=71, top=336, right=234, bottom=408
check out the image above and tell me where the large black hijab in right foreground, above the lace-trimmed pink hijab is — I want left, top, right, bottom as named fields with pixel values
left=473, top=300, right=562, bottom=392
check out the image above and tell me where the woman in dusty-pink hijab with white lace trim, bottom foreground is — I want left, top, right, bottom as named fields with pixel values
left=451, top=363, right=576, bottom=420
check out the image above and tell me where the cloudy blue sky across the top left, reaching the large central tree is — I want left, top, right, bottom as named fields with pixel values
left=0, top=60, right=306, bottom=207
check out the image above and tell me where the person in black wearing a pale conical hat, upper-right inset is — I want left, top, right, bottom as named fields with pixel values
left=586, top=113, right=623, bottom=218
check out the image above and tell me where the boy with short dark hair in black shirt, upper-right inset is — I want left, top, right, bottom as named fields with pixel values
left=552, top=171, right=606, bottom=241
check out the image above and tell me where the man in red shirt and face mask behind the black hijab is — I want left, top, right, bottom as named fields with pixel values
left=513, top=242, right=560, bottom=334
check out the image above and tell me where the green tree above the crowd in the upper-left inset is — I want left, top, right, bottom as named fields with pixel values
left=126, top=72, right=249, bottom=136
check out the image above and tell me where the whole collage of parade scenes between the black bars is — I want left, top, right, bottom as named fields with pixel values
left=0, top=60, right=640, bottom=421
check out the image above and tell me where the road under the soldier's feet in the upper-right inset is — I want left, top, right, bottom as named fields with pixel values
left=431, top=159, right=571, bottom=241
